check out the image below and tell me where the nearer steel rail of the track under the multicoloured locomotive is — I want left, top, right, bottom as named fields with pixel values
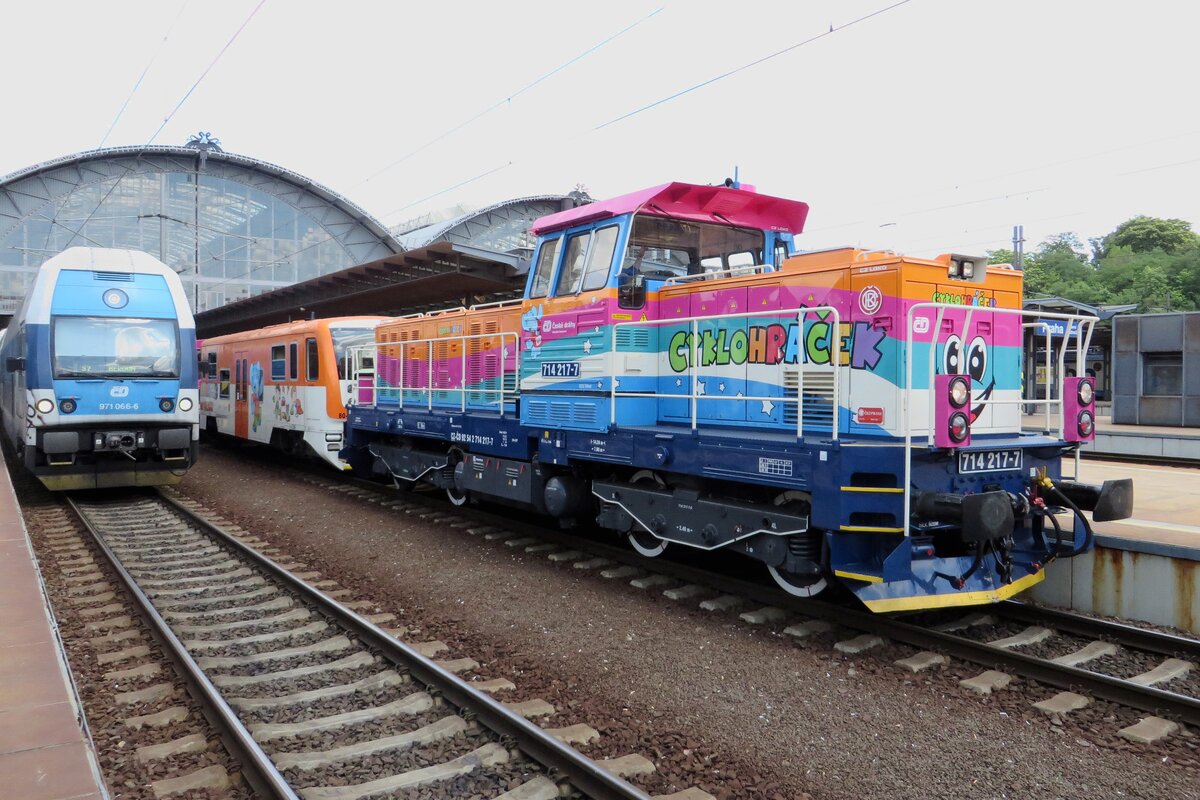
left=328, top=476, right=1200, bottom=726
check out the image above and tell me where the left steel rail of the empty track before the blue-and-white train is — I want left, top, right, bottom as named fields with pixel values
left=66, top=497, right=299, bottom=800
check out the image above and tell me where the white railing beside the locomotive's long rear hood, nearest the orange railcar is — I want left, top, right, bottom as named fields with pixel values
left=346, top=331, right=521, bottom=417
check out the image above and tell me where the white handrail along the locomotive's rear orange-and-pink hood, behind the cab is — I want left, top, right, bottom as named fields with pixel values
left=346, top=331, right=521, bottom=417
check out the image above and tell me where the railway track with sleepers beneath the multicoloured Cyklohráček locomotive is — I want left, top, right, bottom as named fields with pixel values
left=300, top=475, right=1200, bottom=727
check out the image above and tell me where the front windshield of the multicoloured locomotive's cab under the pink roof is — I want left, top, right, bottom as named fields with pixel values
left=622, top=215, right=763, bottom=281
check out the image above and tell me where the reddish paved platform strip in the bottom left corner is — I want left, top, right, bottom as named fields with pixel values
left=0, top=465, right=108, bottom=800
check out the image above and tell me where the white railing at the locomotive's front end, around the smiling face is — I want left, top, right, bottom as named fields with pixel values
left=901, top=302, right=1099, bottom=536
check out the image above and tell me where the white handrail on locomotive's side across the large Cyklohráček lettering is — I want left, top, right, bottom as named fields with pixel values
left=608, top=306, right=842, bottom=440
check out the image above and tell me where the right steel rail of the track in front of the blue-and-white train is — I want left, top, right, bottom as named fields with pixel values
left=156, top=491, right=650, bottom=800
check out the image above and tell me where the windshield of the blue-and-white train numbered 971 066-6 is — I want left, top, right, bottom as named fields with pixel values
left=52, top=317, right=179, bottom=378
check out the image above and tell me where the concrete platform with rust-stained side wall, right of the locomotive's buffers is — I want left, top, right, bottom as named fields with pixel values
left=1030, top=459, right=1200, bottom=636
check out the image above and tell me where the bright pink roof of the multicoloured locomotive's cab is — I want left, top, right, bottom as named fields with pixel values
left=533, top=184, right=809, bottom=235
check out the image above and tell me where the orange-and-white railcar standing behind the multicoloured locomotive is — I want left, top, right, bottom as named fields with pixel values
left=197, top=317, right=388, bottom=469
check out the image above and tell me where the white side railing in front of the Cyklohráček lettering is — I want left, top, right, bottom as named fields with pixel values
left=608, top=306, right=841, bottom=439
